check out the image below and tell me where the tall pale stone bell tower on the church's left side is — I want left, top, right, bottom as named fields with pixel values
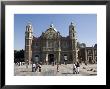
left=25, top=23, right=33, bottom=64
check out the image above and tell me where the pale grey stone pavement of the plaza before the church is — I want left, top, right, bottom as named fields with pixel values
left=14, top=64, right=97, bottom=76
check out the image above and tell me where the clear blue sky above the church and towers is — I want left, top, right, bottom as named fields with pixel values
left=14, top=14, right=97, bottom=50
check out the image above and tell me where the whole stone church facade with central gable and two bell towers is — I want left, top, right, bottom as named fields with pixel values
left=25, top=22, right=78, bottom=64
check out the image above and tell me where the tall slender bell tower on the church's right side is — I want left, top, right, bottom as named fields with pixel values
left=69, top=22, right=77, bottom=62
